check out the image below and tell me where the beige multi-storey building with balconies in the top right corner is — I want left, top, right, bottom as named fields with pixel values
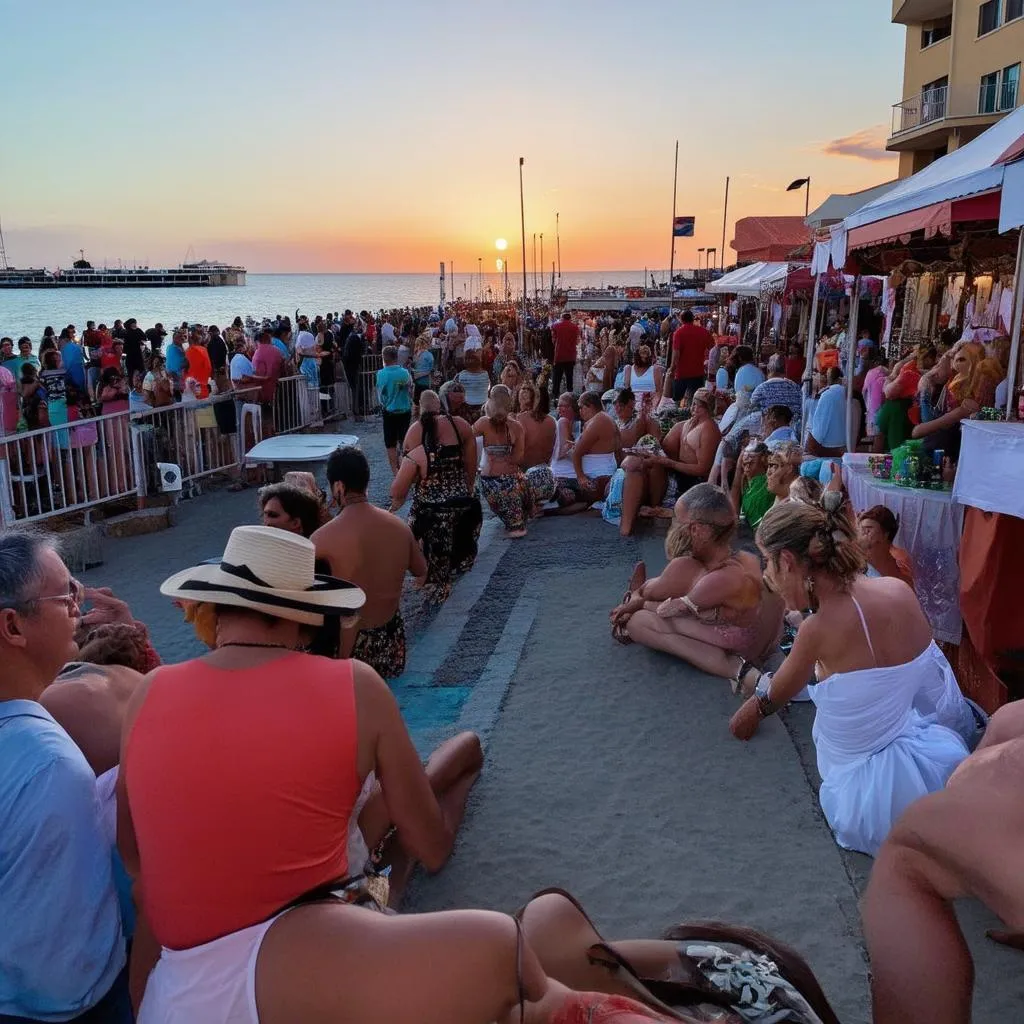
left=886, top=0, right=1024, bottom=178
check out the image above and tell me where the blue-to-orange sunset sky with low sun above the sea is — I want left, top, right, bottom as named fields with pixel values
left=0, top=0, right=903, bottom=272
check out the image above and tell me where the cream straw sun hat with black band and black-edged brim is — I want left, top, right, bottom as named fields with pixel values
left=160, top=526, right=367, bottom=626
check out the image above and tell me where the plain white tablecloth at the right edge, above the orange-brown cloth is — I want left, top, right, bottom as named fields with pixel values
left=953, top=420, right=1024, bottom=519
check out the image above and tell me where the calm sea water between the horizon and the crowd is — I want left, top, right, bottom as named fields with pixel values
left=0, top=267, right=668, bottom=342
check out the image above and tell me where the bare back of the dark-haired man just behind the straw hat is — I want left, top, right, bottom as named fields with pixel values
left=311, top=503, right=423, bottom=629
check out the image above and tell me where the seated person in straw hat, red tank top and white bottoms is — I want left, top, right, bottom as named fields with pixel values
left=118, top=526, right=497, bottom=1024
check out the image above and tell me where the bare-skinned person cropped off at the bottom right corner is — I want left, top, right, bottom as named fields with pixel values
left=861, top=703, right=1024, bottom=1024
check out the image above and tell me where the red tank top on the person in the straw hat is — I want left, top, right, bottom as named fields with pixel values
left=121, top=653, right=361, bottom=949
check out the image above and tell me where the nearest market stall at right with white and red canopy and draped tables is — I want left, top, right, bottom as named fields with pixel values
left=831, top=109, right=1024, bottom=711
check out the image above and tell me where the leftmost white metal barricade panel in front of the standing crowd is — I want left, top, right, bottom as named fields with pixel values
left=0, top=412, right=139, bottom=525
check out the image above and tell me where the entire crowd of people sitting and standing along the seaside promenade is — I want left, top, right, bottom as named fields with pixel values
left=0, top=296, right=1024, bottom=1024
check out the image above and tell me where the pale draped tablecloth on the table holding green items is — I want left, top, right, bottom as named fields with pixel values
left=843, top=466, right=964, bottom=644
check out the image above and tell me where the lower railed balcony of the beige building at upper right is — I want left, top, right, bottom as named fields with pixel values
left=886, top=82, right=1020, bottom=153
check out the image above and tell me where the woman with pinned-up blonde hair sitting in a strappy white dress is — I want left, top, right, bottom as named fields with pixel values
left=730, top=492, right=980, bottom=856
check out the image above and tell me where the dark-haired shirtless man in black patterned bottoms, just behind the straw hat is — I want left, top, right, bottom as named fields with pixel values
left=310, top=447, right=427, bottom=679
